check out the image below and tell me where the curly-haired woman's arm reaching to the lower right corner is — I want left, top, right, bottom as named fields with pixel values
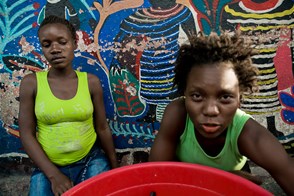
left=238, top=119, right=294, bottom=195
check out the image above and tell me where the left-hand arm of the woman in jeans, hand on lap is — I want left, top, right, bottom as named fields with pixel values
left=18, top=74, right=73, bottom=194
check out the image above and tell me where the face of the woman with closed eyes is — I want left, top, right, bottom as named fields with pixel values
left=39, top=23, right=77, bottom=69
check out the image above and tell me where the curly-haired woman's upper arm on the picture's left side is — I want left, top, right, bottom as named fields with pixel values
left=149, top=98, right=187, bottom=161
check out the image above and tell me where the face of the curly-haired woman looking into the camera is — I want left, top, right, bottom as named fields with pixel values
left=184, top=63, right=240, bottom=138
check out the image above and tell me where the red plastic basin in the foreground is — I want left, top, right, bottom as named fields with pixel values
left=63, top=162, right=272, bottom=196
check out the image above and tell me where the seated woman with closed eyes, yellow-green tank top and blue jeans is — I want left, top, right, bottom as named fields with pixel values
left=19, top=16, right=118, bottom=196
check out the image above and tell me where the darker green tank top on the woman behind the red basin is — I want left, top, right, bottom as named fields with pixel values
left=176, top=109, right=250, bottom=171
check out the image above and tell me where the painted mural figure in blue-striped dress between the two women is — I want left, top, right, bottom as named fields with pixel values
left=110, top=0, right=196, bottom=122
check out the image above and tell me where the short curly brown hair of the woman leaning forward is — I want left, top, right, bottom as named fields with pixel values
left=174, top=31, right=258, bottom=95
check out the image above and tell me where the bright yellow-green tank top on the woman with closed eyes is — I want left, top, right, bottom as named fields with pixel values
left=35, top=71, right=97, bottom=166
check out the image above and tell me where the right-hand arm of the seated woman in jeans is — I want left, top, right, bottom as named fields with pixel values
left=88, top=74, right=118, bottom=168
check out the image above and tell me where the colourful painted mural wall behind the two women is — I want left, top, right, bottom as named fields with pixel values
left=0, top=0, right=294, bottom=163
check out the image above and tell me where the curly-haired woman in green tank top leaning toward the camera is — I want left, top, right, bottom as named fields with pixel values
left=149, top=32, right=294, bottom=195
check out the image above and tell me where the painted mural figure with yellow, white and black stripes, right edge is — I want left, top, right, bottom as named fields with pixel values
left=221, top=0, right=294, bottom=155
